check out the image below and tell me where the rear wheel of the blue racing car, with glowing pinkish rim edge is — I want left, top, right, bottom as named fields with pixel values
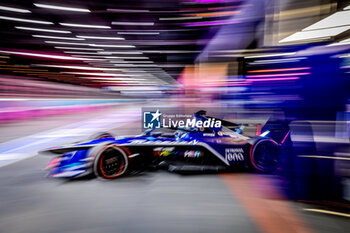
left=249, top=138, right=282, bottom=173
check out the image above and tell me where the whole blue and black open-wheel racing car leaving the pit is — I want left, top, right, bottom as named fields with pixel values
left=44, top=111, right=290, bottom=179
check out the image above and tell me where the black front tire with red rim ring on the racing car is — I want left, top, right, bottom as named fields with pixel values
left=93, top=144, right=129, bottom=179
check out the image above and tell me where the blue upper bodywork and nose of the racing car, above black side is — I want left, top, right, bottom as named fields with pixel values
left=47, top=128, right=254, bottom=177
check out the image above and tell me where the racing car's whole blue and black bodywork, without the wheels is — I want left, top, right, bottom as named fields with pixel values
left=46, top=111, right=279, bottom=177
